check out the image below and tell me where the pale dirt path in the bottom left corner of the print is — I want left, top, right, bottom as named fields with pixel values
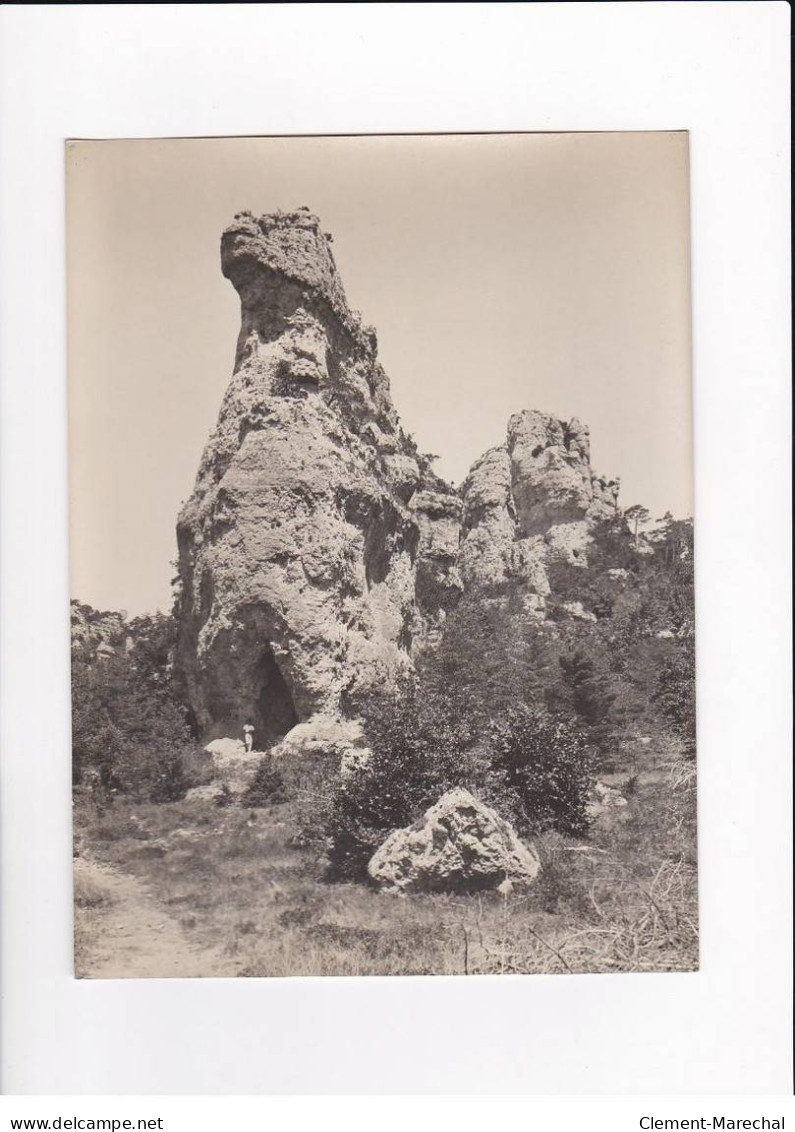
left=75, top=857, right=239, bottom=979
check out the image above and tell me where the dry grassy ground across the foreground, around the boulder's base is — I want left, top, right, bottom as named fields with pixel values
left=76, top=753, right=698, bottom=976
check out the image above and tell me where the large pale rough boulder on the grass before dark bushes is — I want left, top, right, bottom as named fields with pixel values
left=367, top=788, right=541, bottom=892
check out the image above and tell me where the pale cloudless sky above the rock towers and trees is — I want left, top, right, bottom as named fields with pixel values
left=67, top=132, right=692, bottom=614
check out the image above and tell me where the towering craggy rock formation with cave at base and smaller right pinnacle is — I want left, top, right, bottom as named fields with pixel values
left=178, top=208, right=617, bottom=747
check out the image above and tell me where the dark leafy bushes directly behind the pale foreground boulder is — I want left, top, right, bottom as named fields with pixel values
left=323, top=680, right=592, bottom=880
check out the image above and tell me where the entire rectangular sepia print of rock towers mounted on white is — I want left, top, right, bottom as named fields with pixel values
left=67, top=134, right=698, bottom=977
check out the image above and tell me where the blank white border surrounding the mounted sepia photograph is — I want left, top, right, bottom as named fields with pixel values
left=0, top=2, right=792, bottom=1095
